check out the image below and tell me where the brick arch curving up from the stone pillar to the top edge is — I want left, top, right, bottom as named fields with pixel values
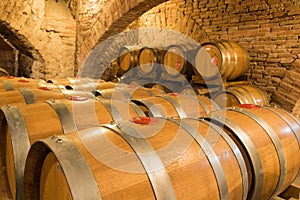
left=76, top=0, right=167, bottom=68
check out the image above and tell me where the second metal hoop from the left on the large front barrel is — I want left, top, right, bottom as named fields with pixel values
left=105, top=123, right=176, bottom=200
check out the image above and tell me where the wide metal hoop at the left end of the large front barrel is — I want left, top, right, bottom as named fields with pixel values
left=40, top=135, right=102, bottom=200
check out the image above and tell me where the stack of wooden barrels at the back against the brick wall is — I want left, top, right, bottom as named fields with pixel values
left=112, top=41, right=270, bottom=108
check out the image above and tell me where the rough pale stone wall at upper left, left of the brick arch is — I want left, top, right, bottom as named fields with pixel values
left=0, top=0, right=76, bottom=79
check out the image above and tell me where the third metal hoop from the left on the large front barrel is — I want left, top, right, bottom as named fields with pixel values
left=168, top=119, right=229, bottom=200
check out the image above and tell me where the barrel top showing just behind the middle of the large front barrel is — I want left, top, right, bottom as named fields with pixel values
left=132, top=93, right=219, bottom=119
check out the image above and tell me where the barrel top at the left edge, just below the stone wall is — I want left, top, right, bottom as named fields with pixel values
left=0, top=76, right=47, bottom=92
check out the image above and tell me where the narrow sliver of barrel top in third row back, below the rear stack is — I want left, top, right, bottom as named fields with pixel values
left=95, top=85, right=164, bottom=100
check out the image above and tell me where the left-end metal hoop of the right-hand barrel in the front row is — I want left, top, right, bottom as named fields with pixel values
left=207, top=115, right=264, bottom=200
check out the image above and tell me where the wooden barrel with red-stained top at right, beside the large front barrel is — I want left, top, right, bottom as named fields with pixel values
left=207, top=104, right=300, bottom=200
